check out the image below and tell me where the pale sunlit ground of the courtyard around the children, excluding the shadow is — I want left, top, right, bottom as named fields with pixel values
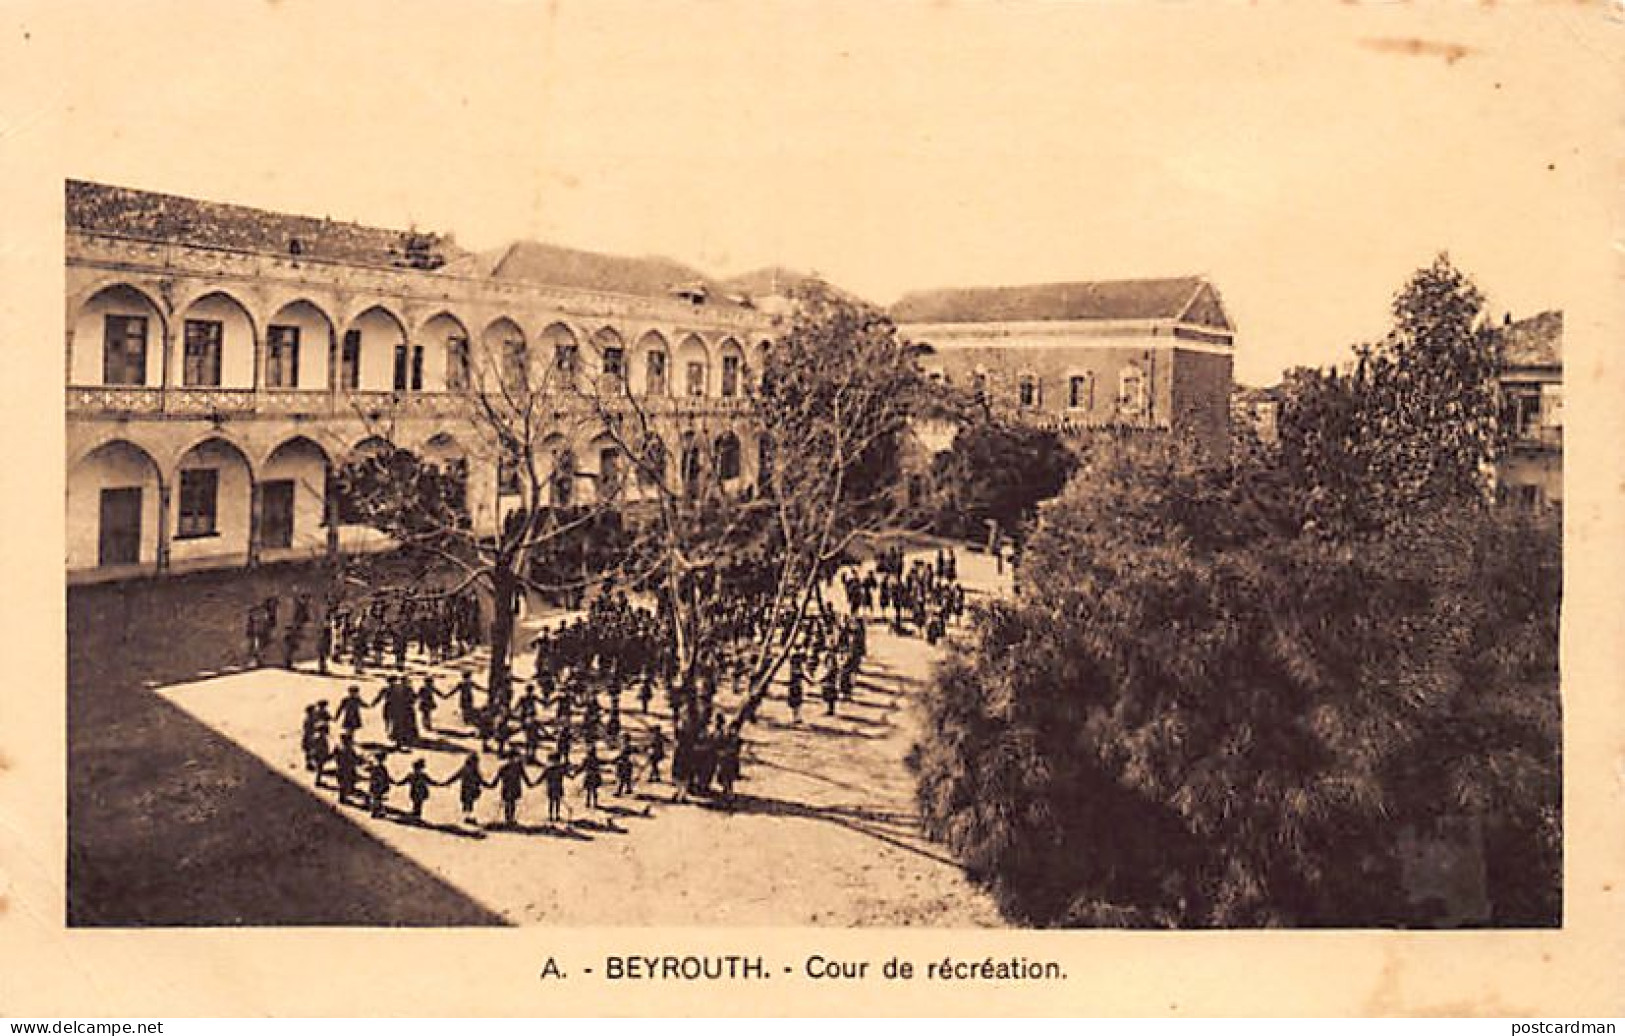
left=159, top=552, right=999, bottom=927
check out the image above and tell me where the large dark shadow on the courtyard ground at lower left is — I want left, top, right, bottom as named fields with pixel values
left=67, top=558, right=505, bottom=927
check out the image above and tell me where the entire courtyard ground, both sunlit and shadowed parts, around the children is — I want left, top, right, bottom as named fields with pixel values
left=70, top=550, right=1003, bottom=927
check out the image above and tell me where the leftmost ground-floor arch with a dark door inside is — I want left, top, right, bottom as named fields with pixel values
left=65, top=437, right=164, bottom=572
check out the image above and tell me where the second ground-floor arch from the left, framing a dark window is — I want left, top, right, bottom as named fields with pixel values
left=169, top=432, right=255, bottom=562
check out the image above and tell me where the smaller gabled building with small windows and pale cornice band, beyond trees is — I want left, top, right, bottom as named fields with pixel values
left=892, top=278, right=1235, bottom=456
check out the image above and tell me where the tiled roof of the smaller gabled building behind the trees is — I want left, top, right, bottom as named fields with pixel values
left=892, top=278, right=1229, bottom=326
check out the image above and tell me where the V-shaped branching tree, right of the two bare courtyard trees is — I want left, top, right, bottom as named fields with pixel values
left=574, top=284, right=926, bottom=729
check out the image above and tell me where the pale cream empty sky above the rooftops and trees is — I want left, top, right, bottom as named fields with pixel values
left=13, top=0, right=1619, bottom=385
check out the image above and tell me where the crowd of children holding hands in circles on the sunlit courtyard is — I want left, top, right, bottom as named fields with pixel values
left=302, top=552, right=964, bottom=825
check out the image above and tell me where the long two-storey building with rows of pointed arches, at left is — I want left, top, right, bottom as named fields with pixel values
left=65, top=182, right=774, bottom=581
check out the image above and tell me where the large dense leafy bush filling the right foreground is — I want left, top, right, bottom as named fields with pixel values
left=915, top=443, right=1562, bottom=927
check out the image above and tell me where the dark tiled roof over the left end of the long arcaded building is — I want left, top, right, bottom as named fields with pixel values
left=67, top=180, right=466, bottom=270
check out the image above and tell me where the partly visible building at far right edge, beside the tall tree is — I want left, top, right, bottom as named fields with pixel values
left=1495, top=310, right=1563, bottom=510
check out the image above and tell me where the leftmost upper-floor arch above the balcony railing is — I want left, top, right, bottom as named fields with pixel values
left=68, top=281, right=169, bottom=388
